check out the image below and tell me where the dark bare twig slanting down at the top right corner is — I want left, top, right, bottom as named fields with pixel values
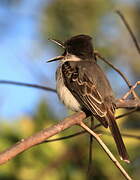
left=116, top=10, right=140, bottom=54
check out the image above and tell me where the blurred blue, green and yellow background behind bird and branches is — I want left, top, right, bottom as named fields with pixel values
left=0, top=0, right=140, bottom=180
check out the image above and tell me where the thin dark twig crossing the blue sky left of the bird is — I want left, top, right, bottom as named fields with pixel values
left=0, top=80, right=56, bottom=93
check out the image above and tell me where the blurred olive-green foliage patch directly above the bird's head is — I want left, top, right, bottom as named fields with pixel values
left=42, top=0, right=114, bottom=39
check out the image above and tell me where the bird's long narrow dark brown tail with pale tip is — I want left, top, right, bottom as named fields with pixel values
left=107, top=109, right=130, bottom=163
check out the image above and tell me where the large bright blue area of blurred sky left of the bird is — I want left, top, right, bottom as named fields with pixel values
left=0, top=0, right=61, bottom=118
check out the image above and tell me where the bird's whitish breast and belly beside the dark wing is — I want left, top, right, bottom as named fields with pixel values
left=56, top=66, right=81, bottom=111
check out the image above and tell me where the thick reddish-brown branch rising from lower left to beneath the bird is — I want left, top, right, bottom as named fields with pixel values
left=0, top=112, right=86, bottom=164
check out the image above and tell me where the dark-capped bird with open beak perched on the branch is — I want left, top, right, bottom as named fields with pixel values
left=48, top=34, right=130, bottom=163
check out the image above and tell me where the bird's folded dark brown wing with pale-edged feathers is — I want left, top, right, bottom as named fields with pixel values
left=62, top=62, right=108, bottom=127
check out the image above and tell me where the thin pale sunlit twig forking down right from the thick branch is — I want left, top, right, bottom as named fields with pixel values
left=79, top=122, right=132, bottom=180
